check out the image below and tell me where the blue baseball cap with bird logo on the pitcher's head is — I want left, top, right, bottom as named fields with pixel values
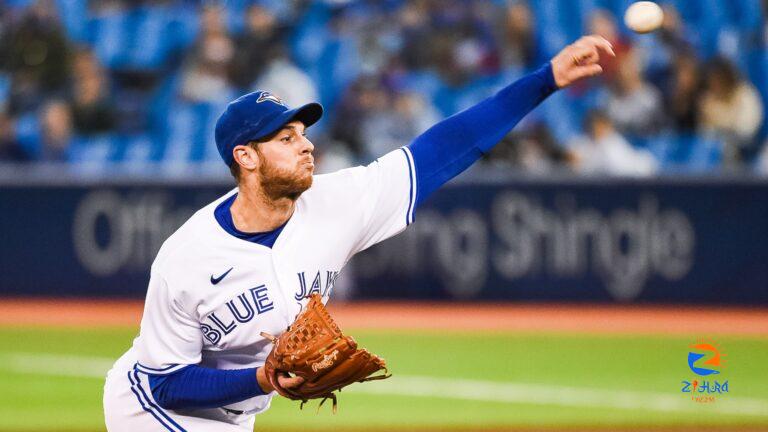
left=215, top=91, right=323, bottom=166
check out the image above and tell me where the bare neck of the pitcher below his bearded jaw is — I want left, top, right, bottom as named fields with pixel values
left=230, top=181, right=296, bottom=233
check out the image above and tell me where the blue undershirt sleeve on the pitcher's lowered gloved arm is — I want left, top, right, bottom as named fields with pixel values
left=149, top=365, right=265, bottom=409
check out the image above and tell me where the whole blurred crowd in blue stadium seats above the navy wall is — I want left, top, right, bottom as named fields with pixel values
left=0, top=0, right=768, bottom=176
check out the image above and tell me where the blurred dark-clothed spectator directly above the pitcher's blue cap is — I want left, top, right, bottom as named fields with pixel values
left=230, top=3, right=288, bottom=89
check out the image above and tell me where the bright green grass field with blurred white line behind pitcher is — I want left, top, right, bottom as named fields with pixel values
left=0, top=328, right=768, bottom=432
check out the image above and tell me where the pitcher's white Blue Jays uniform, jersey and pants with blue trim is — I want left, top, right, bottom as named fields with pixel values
left=104, top=147, right=416, bottom=432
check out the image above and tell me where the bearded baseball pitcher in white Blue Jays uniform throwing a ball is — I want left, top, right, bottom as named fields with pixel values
left=104, top=36, right=613, bottom=432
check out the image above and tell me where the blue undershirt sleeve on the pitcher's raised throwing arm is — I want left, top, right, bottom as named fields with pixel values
left=408, top=63, right=557, bottom=205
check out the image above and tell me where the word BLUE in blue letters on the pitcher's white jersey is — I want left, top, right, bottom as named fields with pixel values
left=200, top=285, right=275, bottom=345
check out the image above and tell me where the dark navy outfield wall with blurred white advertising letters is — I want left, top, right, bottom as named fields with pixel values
left=0, top=173, right=768, bottom=305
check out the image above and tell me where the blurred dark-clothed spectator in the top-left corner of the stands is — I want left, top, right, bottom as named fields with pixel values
left=0, top=0, right=70, bottom=114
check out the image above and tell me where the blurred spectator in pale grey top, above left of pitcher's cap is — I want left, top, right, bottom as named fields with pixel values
left=181, top=6, right=235, bottom=102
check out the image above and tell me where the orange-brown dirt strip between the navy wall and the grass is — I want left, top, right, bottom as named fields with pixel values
left=0, top=299, right=768, bottom=338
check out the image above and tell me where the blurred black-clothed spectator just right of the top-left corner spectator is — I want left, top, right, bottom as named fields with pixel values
left=71, top=50, right=115, bottom=135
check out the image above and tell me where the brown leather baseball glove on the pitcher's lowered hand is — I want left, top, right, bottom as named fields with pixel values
left=261, top=294, right=392, bottom=413
